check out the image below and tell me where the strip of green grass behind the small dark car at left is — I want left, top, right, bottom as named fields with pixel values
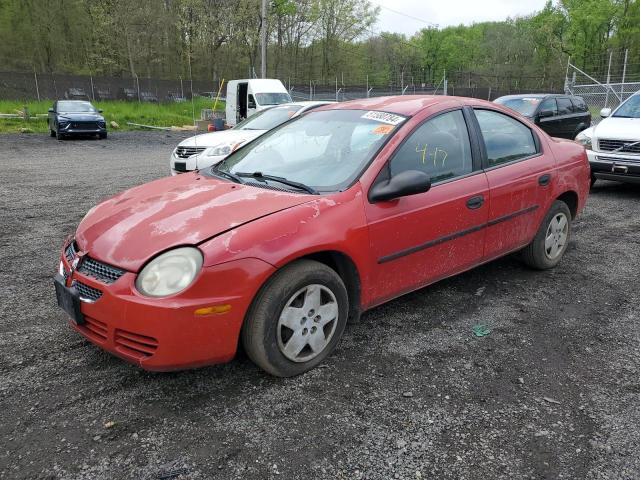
left=0, top=97, right=225, bottom=133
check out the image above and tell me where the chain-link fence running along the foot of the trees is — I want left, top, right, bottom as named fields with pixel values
left=0, top=68, right=560, bottom=102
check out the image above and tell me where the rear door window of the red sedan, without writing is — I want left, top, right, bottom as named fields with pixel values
left=475, top=110, right=537, bottom=167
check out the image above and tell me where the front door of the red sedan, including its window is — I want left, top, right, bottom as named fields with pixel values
left=365, top=110, right=488, bottom=303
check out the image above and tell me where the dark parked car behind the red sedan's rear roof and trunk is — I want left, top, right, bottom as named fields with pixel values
left=495, top=93, right=591, bottom=140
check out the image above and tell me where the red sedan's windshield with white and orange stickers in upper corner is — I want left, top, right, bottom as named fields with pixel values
left=213, top=110, right=406, bottom=192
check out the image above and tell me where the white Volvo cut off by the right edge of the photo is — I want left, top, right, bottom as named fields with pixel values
left=576, top=92, right=640, bottom=185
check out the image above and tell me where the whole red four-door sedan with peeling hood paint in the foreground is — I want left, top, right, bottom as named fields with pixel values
left=55, top=96, right=590, bottom=376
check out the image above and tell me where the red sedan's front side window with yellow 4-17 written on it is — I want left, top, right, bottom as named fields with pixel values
left=389, top=110, right=473, bottom=183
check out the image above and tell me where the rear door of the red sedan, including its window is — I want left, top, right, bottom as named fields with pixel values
left=474, top=108, right=555, bottom=259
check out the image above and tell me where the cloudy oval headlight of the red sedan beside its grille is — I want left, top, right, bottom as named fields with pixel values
left=136, top=247, right=202, bottom=297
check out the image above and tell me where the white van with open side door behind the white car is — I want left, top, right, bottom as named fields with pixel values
left=225, top=78, right=291, bottom=127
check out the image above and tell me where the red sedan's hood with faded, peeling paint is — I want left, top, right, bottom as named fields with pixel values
left=76, top=174, right=316, bottom=272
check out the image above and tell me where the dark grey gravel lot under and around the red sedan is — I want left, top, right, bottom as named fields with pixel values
left=0, top=133, right=640, bottom=479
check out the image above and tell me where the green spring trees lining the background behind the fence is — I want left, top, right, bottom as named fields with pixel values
left=0, top=0, right=640, bottom=88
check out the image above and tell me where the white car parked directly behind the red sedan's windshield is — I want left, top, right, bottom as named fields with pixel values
left=169, top=101, right=335, bottom=175
